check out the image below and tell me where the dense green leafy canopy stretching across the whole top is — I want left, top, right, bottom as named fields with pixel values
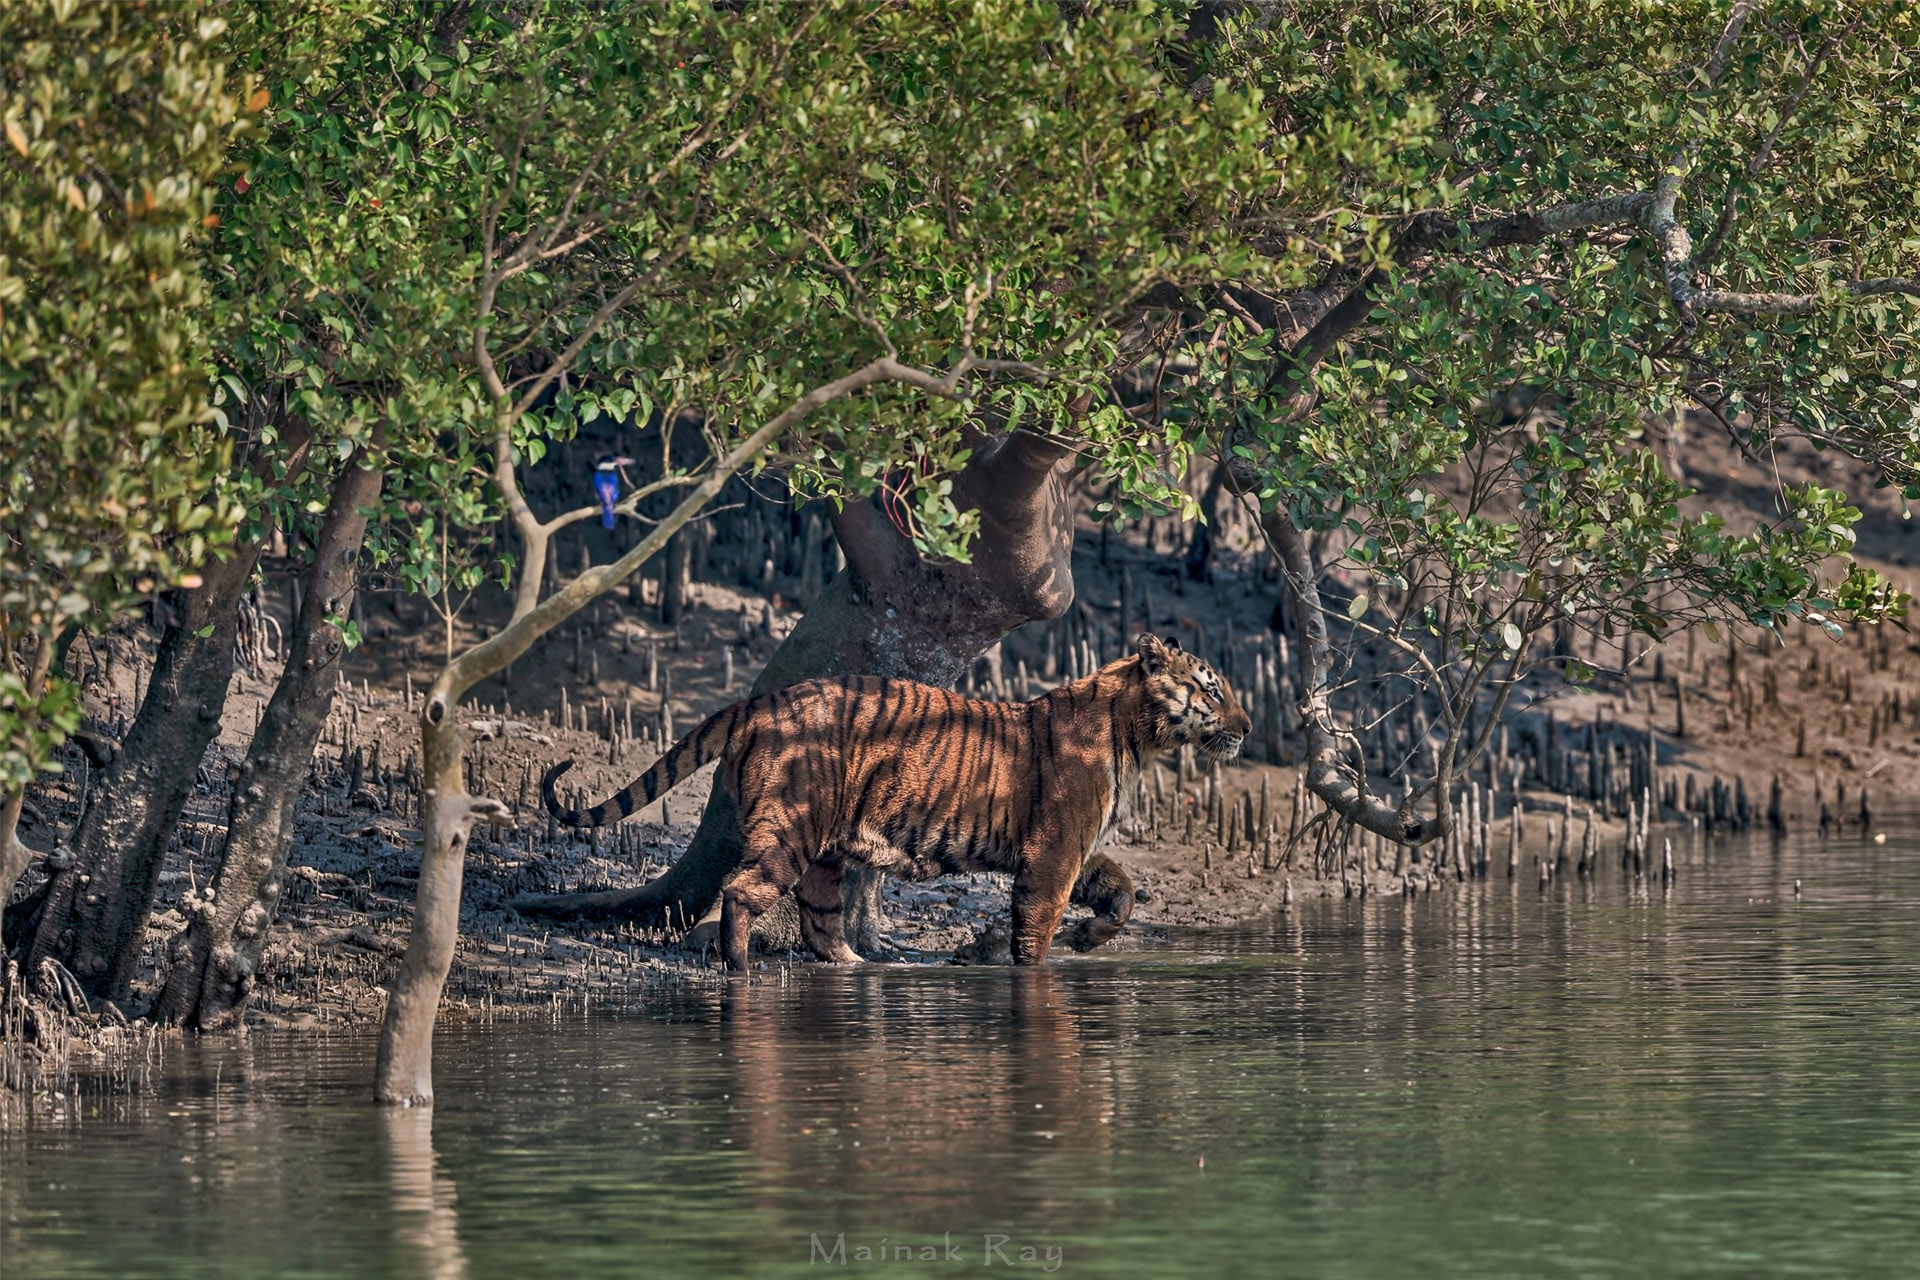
left=0, top=0, right=1920, bottom=832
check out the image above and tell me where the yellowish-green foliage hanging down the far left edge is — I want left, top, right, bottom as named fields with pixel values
left=0, top=0, right=263, bottom=785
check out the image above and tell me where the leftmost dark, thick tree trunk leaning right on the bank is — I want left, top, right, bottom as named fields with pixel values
left=27, top=543, right=261, bottom=1004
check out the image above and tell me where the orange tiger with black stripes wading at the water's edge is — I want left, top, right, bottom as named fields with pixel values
left=540, top=633, right=1252, bottom=973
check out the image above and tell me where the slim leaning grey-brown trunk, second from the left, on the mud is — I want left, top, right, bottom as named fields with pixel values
left=154, top=449, right=384, bottom=1031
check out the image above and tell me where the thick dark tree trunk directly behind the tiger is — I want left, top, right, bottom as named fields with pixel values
left=515, top=434, right=1073, bottom=950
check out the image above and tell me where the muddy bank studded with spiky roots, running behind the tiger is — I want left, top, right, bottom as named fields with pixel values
left=23, top=479, right=1920, bottom=1025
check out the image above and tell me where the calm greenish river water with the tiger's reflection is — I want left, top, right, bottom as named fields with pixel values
left=0, top=837, right=1920, bottom=1280
